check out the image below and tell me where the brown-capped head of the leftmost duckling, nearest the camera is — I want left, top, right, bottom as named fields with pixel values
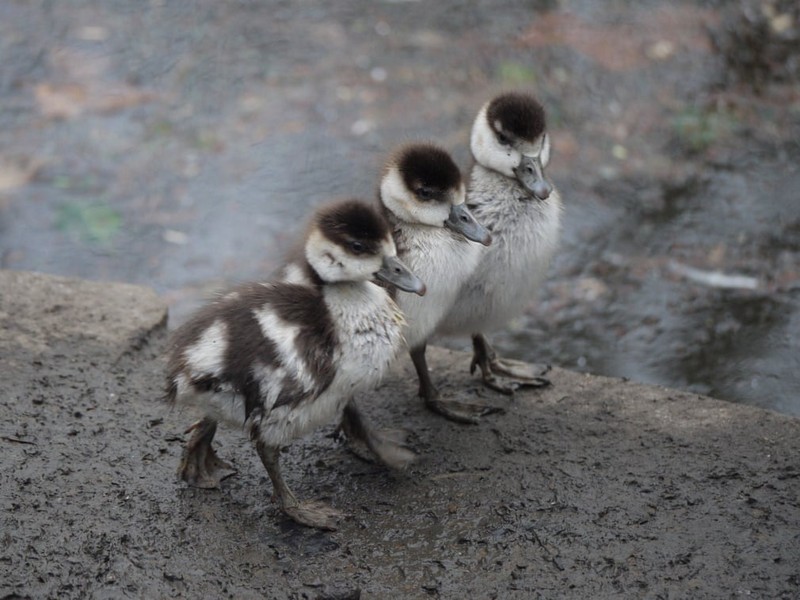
left=305, top=200, right=425, bottom=296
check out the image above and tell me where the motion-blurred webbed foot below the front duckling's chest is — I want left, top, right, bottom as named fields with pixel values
left=342, top=400, right=417, bottom=470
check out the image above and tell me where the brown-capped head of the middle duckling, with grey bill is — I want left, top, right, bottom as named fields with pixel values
left=380, top=144, right=491, bottom=246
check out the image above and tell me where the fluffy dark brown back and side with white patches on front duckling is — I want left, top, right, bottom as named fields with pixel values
left=167, top=283, right=336, bottom=421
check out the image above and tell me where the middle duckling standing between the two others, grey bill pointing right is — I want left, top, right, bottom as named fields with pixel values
left=342, top=143, right=491, bottom=458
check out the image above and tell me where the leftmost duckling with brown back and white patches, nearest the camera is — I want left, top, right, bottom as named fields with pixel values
left=166, top=200, right=425, bottom=530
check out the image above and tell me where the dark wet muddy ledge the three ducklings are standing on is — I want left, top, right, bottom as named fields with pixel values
left=0, top=271, right=800, bottom=599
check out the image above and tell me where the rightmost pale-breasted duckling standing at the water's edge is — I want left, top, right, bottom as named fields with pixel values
left=437, top=92, right=562, bottom=418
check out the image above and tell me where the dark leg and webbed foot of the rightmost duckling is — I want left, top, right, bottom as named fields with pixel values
left=469, top=333, right=550, bottom=396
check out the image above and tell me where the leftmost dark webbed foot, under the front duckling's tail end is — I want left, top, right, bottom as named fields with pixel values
left=178, top=417, right=236, bottom=489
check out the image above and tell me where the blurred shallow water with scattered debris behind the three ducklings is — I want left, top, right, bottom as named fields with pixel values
left=0, top=0, right=800, bottom=415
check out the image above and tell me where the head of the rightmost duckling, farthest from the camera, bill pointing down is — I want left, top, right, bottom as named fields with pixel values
left=470, top=92, right=553, bottom=200
